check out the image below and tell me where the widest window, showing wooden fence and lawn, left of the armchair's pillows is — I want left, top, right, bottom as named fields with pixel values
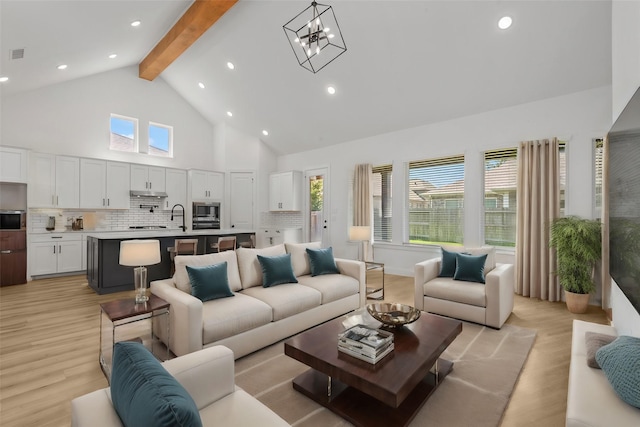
left=408, top=155, right=464, bottom=245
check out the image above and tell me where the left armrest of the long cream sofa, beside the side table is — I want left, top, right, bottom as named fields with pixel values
left=151, top=279, right=202, bottom=356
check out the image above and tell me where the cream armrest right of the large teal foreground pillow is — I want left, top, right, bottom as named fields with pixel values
left=163, top=345, right=235, bottom=410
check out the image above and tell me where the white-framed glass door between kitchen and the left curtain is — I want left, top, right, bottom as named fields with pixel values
left=305, top=168, right=331, bottom=248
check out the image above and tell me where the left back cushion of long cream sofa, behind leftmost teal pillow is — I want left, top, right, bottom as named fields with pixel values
left=173, top=251, right=242, bottom=294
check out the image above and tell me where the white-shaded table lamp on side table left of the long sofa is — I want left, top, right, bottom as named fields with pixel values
left=120, top=240, right=160, bottom=304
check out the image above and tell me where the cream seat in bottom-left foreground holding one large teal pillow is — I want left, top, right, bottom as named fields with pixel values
left=71, top=346, right=289, bottom=427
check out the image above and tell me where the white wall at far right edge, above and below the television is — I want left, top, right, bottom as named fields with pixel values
left=611, top=0, right=640, bottom=336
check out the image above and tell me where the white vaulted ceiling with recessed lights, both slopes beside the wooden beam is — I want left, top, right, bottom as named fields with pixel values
left=0, top=0, right=611, bottom=153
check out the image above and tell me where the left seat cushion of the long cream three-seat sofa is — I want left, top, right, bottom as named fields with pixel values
left=202, top=294, right=272, bottom=345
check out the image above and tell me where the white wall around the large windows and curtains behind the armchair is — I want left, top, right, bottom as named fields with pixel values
left=278, top=86, right=611, bottom=275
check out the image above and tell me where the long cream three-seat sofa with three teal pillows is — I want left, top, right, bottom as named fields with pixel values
left=151, top=242, right=366, bottom=358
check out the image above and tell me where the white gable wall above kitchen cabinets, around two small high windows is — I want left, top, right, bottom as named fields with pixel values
left=0, top=66, right=218, bottom=170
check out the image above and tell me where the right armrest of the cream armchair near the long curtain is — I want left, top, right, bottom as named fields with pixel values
left=485, top=264, right=515, bottom=329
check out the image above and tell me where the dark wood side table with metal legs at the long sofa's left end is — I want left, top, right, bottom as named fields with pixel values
left=99, top=294, right=171, bottom=383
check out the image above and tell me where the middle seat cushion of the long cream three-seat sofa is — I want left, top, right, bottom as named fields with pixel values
left=242, top=283, right=322, bottom=322
